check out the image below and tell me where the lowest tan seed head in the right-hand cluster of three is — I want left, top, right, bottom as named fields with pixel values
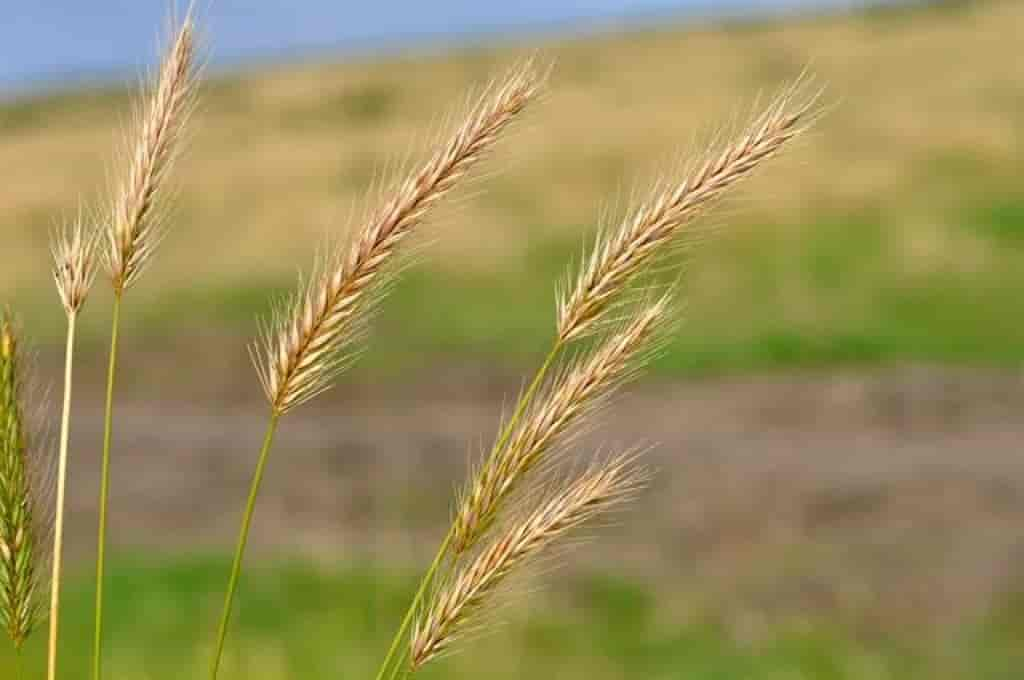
left=410, top=454, right=645, bottom=670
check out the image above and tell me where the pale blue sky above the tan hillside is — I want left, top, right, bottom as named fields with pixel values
left=0, top=0, right=864, bottom=89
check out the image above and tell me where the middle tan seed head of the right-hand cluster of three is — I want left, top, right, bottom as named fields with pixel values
left=453, top=293, right=671, bottom=554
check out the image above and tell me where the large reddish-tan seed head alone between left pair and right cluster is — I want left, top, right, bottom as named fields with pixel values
left=256, top=62, right=542, bottom=414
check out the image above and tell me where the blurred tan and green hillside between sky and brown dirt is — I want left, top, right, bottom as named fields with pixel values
left=0, top=1, right=1024, bottom=371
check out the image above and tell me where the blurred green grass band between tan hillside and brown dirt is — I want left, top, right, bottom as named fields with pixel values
left=19, top=200, right=1024, bottom=376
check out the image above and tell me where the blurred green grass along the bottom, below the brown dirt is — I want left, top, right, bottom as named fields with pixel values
left=0, top=559, right=1024, bottom=680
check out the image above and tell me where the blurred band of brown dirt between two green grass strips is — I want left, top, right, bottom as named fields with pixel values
left=37, top=355, right=1024, bottom=630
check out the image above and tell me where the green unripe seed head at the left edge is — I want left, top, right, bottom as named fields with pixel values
left=0, top=315, right=40, bottom=648
